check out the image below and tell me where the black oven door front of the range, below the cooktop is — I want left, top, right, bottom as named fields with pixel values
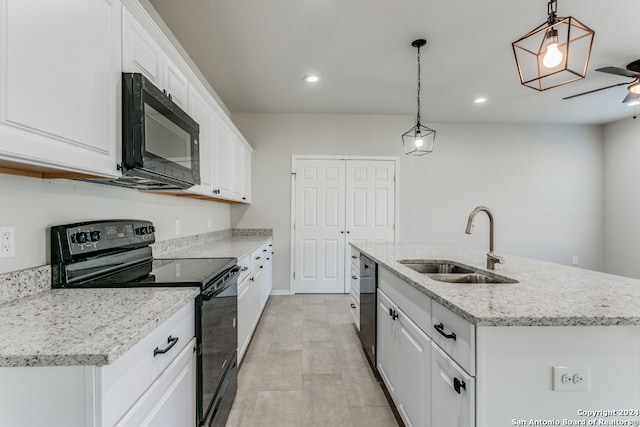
left=196, top=274, right=238, bottom=425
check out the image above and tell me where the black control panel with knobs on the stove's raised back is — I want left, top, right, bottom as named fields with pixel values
left=51, top=220, right=155, bottom=262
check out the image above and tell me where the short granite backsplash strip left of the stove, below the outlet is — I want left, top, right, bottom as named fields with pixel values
left=0, top=265, right=51, bottom=304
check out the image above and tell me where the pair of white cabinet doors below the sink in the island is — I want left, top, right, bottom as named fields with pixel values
left=377, top=290, right=431, bottom=427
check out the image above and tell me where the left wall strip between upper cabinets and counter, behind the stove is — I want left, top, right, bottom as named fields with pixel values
left=0, top=174, right=230, bottom=273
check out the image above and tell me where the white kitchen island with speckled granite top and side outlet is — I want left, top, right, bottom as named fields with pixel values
left=354, top=243, right=640, bottom=427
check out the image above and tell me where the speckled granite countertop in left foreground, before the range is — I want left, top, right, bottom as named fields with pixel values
left=0, top=288, right=200, bottom=366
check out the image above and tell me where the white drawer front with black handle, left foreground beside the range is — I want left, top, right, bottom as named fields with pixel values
left=96, top=301, right=195, bottom=426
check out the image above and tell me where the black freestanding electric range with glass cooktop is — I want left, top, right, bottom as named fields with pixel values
left=50, top=220, right=240, bottom=426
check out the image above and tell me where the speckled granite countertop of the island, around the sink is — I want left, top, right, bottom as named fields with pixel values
left=352, top=243, right=640, bottom=326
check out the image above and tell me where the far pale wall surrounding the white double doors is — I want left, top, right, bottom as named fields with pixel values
left=231, top=113, right=604, bottom=290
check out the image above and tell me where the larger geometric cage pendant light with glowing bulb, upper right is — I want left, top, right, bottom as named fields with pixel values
left=511, top=0, right=595, bottom=91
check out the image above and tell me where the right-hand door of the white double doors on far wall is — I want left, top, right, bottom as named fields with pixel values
left=344, top=160, right=396, bottom=293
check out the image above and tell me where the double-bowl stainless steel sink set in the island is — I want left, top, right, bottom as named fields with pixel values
left=399, top=260, right=518, bottom=283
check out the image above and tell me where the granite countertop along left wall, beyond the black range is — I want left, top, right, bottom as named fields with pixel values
left=159, top=236, right=272, bottom=259
